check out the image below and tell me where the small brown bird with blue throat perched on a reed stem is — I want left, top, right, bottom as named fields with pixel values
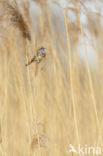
left=26, top=47, right=46, bottom=66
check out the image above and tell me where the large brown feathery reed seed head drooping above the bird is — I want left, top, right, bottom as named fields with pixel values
left=0, top=1, right=31, bottom=40
